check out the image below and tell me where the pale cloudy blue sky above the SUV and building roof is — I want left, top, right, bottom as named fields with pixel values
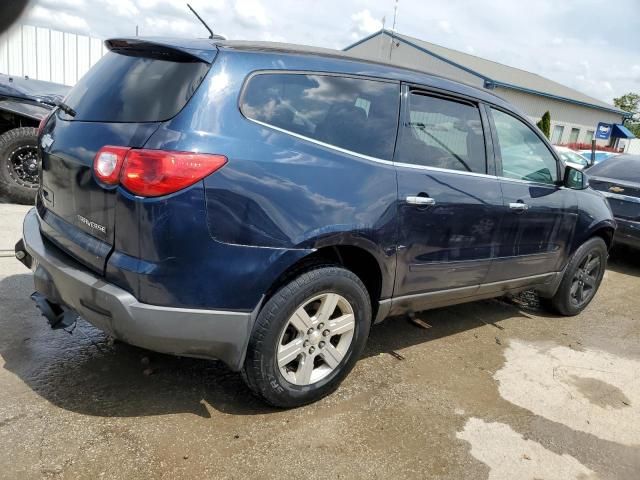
left=21, top=0, right=640, bottom=102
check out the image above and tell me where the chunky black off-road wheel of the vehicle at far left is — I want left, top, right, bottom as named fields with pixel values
left=0, top=127, right=39, bottom=205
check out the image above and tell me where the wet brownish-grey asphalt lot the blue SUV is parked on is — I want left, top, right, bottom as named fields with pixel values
left=0, top=201, right=640, bottom=480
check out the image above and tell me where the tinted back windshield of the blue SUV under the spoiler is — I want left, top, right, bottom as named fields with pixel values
left=63, top=50, right=209, bottom=122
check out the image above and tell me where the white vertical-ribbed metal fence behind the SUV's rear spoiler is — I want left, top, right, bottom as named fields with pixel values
left=0, top=25, right=106, bottom=85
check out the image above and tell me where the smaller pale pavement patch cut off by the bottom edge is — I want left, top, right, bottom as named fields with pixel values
left=456, top=417, right=597, bottom=480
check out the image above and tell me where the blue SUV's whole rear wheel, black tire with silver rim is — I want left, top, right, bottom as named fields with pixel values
left=243, top=266, right=371, bottom=408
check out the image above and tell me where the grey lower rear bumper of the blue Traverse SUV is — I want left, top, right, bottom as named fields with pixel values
left=16, top=209, right=257, bottom=370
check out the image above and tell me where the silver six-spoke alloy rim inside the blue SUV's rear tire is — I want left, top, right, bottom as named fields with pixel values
left=276, top=293, right=356, bottom=385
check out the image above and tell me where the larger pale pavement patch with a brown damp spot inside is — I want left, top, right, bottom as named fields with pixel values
left=494, top=341, right=640, bottom=446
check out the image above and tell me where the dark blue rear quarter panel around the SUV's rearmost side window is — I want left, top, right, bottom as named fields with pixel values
left=141, top=51, right=399, bottom=304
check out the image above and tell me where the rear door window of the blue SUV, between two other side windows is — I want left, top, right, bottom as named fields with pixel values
left=396, top=93, right=487, bottom=173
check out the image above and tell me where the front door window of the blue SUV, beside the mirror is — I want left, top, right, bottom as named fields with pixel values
left=491, top=109, right=558, bottom=183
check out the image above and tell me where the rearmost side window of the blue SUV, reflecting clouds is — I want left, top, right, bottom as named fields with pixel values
left=240, top=73, right=400, bottom=160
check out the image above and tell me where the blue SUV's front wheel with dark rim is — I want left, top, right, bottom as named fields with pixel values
left=546, top=237, right=608, bottom=316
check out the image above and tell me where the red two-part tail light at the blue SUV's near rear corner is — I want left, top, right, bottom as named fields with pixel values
left=93, top=146, right=227, bottom=197
